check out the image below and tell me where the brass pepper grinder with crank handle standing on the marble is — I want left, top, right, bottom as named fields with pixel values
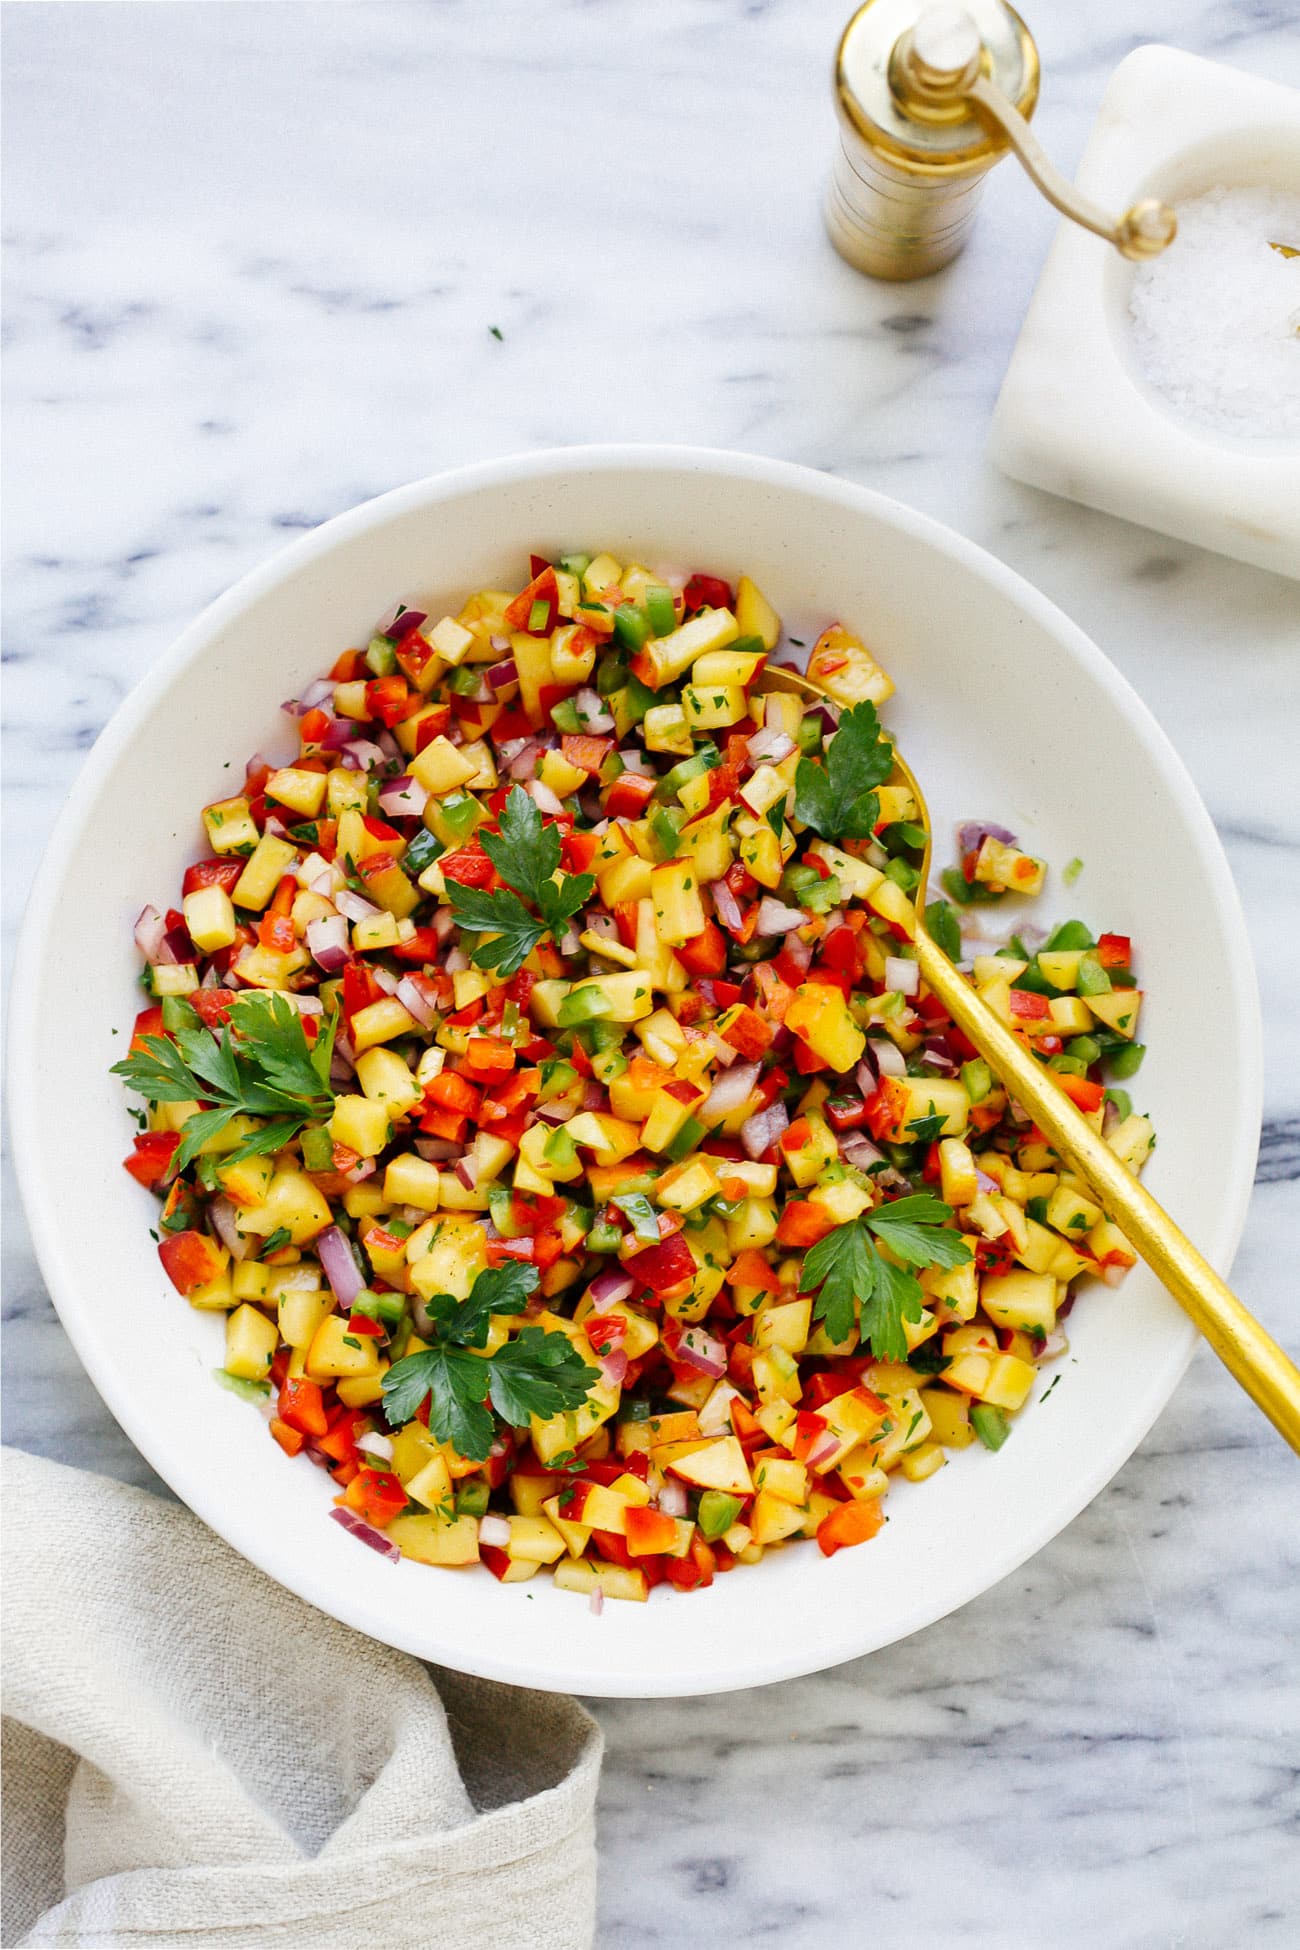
left=826, top=0, right=1177, bottom=279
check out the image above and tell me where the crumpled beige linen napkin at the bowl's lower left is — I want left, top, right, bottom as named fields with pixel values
left=2, top=1451, right=600, bottom=1950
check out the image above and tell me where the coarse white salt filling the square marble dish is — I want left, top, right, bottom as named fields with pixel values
left=1128, top=185, right=1300, bottom=441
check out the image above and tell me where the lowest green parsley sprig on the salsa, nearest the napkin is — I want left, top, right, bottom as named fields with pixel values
left=382, top=1262, right=600, bottom=1463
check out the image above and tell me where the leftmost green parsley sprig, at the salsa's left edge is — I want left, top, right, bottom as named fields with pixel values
left=113, top=991, right=337, bottom=1172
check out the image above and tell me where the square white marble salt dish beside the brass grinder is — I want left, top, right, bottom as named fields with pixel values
left=990, top=47, right=1300, bottom=577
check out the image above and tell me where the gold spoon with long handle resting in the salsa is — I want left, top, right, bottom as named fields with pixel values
left=764, top=665, right=1300, bottom=1453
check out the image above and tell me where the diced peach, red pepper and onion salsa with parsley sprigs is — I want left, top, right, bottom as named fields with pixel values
left=115, top=554, right=1154, bottom=1611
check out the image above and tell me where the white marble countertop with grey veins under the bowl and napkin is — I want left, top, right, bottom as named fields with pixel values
left=4, top=0, right=1300, bottom=1950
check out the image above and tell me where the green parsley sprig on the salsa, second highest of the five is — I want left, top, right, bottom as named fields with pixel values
left=446, top=786, right=596, bottom=975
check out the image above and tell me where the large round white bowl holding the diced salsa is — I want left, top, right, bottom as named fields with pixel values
left=10, top=447, right=1261, bottom=1697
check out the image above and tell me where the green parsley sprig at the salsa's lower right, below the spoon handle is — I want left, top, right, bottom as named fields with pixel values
left=799, top=1191, right=971, bottom=1361
